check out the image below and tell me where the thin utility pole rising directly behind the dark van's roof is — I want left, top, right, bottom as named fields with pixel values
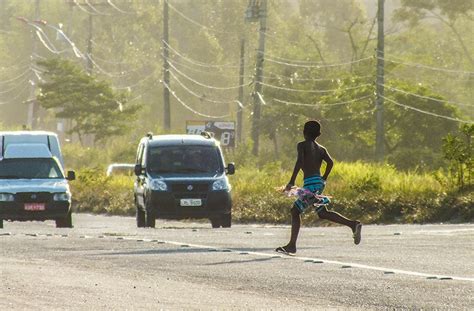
left=163, top=0, right=171, bottom=131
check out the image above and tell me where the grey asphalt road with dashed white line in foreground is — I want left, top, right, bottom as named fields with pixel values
left=0, top=214, right=474, bottom=310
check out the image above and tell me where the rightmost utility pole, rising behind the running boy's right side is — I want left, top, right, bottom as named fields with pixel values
left=375, top=0, right=385, bottom=162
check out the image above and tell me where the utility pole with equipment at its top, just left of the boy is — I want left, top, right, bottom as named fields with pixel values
left=248, top=0, right=267, bottom=156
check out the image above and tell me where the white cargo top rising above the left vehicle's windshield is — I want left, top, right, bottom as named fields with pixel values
left=0, top=131, right=64, bottom=169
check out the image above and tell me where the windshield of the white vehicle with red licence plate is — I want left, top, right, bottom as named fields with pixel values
left=0, top=158, right=64, bottom=179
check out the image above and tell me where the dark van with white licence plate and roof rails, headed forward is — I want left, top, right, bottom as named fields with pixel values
left=134, top=133, right=235, bottom=228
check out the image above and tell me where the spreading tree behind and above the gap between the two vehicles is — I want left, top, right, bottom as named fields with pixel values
left=38, top=58, right=139, bottom=143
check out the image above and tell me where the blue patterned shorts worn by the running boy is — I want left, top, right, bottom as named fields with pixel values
left=295, top=175, right=329, bottom=213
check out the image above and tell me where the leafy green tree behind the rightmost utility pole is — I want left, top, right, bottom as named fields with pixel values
left=322, top=77, right=459, bottom=169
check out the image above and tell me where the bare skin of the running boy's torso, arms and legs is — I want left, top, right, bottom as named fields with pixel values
left=277, top=123, right=360, bottom=254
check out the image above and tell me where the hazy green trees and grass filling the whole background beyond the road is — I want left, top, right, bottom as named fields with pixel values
left=0, top=0, right=474, bottom=223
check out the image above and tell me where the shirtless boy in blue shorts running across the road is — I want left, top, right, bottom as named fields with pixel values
left=275, top=121, right=362, bottom=255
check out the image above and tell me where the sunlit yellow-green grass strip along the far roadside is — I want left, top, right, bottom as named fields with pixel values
left=71, top=162, right=474, bottom=225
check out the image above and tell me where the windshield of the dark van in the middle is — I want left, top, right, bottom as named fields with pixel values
left=147, top=146, right=224, bottom=176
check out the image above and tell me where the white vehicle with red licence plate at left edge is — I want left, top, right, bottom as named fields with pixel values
left=0, top=132, right=76, bottom=229
